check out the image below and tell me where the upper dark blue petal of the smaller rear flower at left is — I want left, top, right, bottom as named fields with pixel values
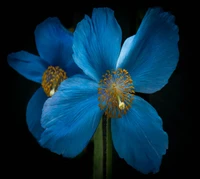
left=35, top=17, right=78, bottom=76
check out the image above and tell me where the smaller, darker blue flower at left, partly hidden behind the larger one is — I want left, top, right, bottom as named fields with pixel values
left=7, top=17, right=82, bottom=140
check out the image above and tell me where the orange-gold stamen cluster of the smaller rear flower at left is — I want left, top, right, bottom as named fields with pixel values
left=42, top=66, right=67, bottom=97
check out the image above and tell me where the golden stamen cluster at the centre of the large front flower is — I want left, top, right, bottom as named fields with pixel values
left=98, top=69, right=135, bottom=118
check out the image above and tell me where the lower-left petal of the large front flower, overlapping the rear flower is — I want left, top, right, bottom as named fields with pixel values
left=40, top=76, right=102, bottom=158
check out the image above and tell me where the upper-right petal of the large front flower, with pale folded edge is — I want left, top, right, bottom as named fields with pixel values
left=117, top=8, right=179, bottom=93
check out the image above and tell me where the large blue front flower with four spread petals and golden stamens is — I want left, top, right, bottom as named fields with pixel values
left=39, top=8, right=179, bottom=174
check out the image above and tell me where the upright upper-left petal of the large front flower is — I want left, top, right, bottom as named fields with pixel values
left=73, top=8, right=122, bottom=82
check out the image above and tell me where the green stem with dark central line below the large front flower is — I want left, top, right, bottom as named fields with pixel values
left=93, top=116, right=112, bottom=179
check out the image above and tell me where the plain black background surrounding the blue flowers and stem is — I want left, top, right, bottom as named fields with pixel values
left=1, top=1, right=193, bottom=178
